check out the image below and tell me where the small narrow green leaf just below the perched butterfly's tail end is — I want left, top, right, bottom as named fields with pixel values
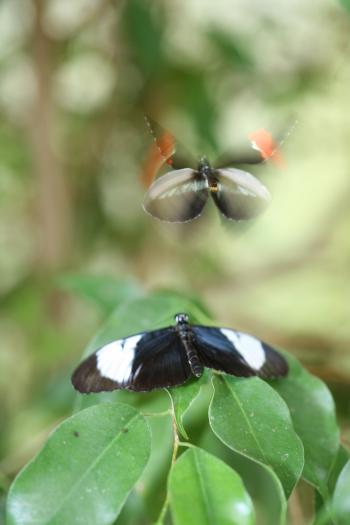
left=168, top=370, right=208, bottom=439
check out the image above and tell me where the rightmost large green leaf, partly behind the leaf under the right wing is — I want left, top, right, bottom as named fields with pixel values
left=271, top=356, right=339, bottom=498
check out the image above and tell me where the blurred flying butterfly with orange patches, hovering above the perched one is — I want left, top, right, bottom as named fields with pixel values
left=143, top=118, right=281, bottom=222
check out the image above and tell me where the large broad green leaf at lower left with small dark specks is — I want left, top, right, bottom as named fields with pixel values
left=7, top=403, right=151, bottom=525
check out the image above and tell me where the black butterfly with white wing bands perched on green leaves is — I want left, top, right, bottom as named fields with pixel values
left=72, top=313, right=288, bottom=393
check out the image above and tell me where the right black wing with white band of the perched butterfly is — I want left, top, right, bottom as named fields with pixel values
left=192, top=326, right=288, bottom=379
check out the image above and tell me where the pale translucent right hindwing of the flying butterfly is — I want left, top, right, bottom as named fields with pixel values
left=211, top=168, right=271, bottom=221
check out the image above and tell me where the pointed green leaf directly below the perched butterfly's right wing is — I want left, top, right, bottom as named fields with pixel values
left=209, top=375, right=303, bottom=497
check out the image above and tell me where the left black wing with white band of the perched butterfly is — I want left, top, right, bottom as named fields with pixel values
left=72, top=327, right=191, bottom=393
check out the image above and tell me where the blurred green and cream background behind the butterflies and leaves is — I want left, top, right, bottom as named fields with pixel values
left=0, top=0, right=350, bottom=516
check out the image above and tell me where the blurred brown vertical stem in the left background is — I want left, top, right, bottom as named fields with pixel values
left=29, top=0, right=72, bottom=270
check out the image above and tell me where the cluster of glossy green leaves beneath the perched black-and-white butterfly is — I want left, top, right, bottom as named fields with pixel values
left=7, top=286, right=349, bottom=525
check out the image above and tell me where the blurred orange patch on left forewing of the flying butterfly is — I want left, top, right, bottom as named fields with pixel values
left=141, top=131, right=175, bottom=188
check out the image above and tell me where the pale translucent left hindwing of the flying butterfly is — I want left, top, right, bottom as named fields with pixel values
left=143, top=168, right=208, bottom=222
